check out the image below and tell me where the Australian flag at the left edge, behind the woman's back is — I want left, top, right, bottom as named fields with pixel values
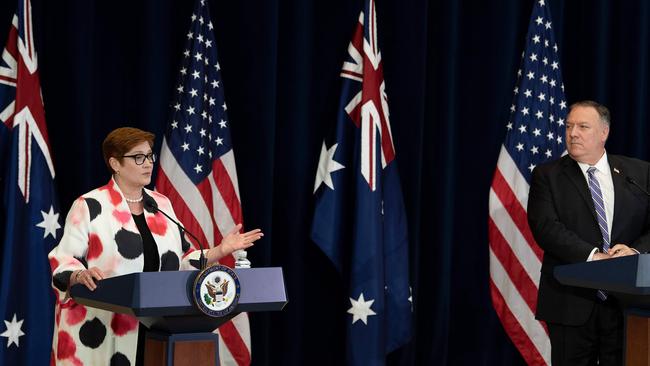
left=0, top=0, right=61, bottom=365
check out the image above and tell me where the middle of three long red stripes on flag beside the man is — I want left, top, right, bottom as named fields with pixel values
left=488, top=217, right=537, bottom=314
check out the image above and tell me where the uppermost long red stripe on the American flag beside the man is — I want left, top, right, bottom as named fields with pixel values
left=492, top=169, right=544, bottom=261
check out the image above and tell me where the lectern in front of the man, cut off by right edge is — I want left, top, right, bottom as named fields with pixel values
left=553, top=254, right=650, bottom=365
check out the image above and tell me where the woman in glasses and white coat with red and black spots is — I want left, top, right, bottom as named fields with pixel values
left=49, top=127, right=263, bottom=365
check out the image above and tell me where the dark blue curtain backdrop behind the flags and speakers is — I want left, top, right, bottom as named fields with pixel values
left=0, top=0, right=650, bottom=365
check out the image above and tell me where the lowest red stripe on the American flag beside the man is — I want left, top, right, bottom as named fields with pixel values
left=490, top=278, right=546, bottom=365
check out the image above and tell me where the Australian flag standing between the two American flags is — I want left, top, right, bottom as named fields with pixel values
left=311, top=0, right=412, bottom=365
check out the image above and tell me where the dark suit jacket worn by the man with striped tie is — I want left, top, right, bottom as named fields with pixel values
left=528, top=154, right=650, bottom=325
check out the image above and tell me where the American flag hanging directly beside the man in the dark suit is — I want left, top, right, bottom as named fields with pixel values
left=488, top=0, right=567, bottom=365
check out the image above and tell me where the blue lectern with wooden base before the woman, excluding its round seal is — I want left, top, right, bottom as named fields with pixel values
left=70, top=267, right=288, bottom=366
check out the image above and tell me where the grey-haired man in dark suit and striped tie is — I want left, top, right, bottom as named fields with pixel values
left=528, top=101, right=650, bottom=366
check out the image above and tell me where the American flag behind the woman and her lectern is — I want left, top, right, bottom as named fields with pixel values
left=156, top=0, right=251, bottom=365
